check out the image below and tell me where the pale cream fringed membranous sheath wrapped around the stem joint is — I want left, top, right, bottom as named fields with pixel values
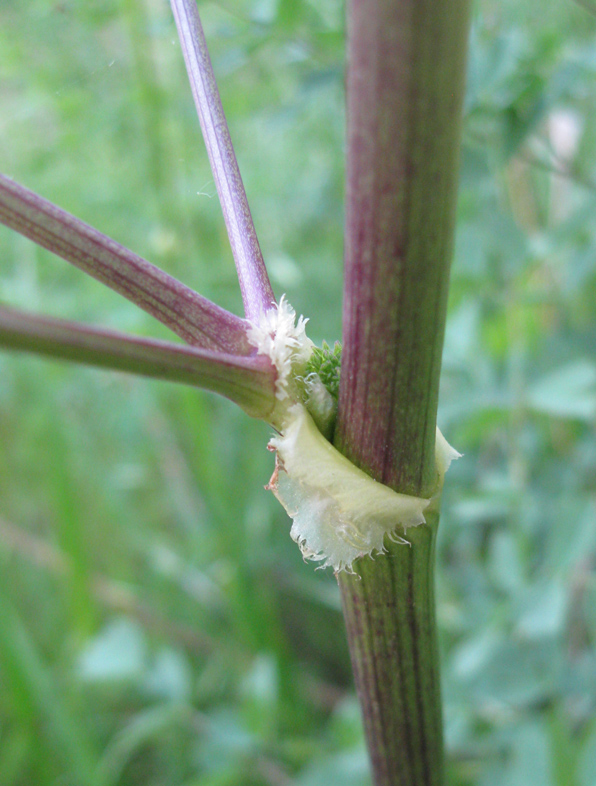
left=249, top=299, right=459, bottom=571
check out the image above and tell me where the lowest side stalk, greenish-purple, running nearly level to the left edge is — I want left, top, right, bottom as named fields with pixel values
left=0, top=306, right=275, bottom=418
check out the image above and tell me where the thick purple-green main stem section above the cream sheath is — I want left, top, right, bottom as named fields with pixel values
left=336, top=0, right=468, bottom=496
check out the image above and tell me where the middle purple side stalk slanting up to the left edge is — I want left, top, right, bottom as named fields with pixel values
left=0, top=174, right=253, bottom=355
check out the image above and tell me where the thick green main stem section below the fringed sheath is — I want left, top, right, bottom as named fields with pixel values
left=339, top=516, right=443, bottom=786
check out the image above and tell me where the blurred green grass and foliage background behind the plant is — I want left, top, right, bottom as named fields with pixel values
left=0, top=0, right=596, bottom=786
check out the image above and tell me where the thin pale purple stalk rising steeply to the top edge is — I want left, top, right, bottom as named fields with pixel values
left=171, top=0, right=275, bottom=322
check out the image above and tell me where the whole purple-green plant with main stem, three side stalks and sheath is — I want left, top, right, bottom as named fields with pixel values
left=0, top=0, right=468, bottom=786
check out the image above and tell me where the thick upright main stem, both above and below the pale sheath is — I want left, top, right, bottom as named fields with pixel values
left=335, top=0, right=469, bottom=786
